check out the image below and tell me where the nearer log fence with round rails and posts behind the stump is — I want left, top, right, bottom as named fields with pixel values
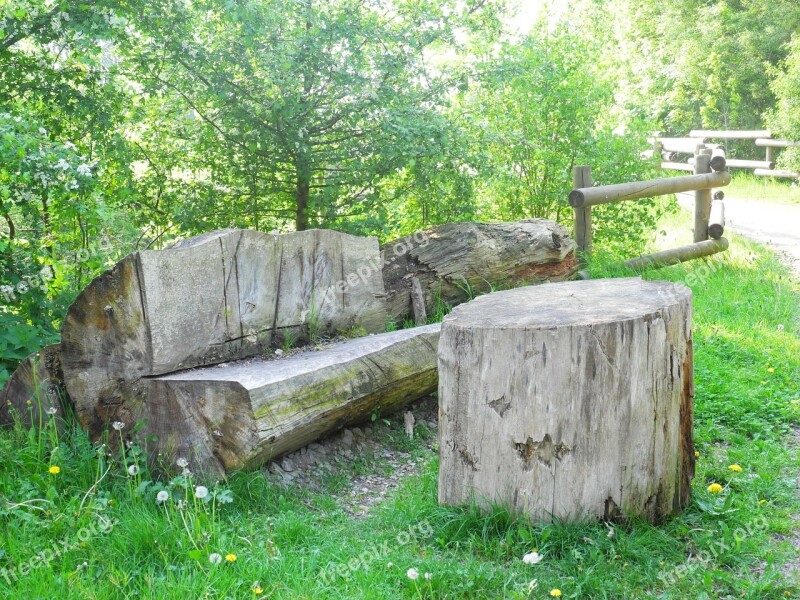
left=569, top=140, right=731, bottom=269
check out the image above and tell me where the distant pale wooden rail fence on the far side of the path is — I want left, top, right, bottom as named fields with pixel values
left=648, top=129, right=800, bottom=179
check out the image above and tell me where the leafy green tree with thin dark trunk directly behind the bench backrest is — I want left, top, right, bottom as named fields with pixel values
left=128, top=0, right=504, bottom=230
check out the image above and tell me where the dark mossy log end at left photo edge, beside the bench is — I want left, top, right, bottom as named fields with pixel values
left=0, top=344, right=67, bottom=427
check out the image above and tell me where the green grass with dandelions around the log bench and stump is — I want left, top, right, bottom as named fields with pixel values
left=0, top=210, right=800, bottom=599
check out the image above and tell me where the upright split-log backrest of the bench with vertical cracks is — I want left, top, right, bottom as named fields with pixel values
left=61, top=230, right=386, bottom=446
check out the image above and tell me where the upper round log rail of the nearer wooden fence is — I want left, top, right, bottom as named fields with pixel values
left=569, top=171, right=731, bottom=208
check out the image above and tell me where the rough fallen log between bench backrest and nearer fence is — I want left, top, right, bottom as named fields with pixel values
left=381, top=219, right=578, bottom=321
